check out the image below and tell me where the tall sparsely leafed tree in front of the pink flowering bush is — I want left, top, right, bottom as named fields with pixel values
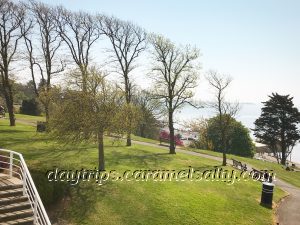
left=150, top=35, right=199, bottom=154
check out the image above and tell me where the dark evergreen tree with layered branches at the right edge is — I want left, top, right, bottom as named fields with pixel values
left=254, top=93, right=300, bottom=165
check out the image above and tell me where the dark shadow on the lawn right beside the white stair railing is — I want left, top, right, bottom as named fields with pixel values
left=23, top=168, right=102, bottom=224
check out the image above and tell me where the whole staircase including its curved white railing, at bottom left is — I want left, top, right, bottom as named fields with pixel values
left=0, top=149, right=51, bottom=225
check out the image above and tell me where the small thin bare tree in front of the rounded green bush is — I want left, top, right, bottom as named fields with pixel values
left=207, top=70, right=239, bottom=166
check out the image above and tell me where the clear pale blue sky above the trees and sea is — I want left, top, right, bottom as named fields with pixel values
left=39, top=0, right=300, bottom=106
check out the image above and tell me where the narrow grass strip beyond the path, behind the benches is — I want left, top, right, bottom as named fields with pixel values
left=186, top=148, right=300, bottom=187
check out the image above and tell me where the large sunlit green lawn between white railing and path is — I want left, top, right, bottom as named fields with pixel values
left=0, top=119, right=285, bottom=225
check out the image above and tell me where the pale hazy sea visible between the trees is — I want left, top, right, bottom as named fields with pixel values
left=175, top=103, right=300, bottom=163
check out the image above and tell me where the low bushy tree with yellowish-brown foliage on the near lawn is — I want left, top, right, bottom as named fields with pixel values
left=49, top=68, right=126, bottom=170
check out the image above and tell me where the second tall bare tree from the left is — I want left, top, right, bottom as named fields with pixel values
left=24, top=1, right=65, bottom=122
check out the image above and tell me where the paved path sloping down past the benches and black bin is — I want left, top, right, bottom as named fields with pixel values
left=132, top=141, right=300, bottom=225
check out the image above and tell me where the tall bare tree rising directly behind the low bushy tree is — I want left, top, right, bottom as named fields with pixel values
left=56, top=7, right=101, bottom=92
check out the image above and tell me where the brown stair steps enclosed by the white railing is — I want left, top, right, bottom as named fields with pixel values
left=0, top=174, right=34, bottom=225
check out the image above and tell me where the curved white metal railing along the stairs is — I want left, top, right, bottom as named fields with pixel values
left=0, top=149, right=51, bottom=225
